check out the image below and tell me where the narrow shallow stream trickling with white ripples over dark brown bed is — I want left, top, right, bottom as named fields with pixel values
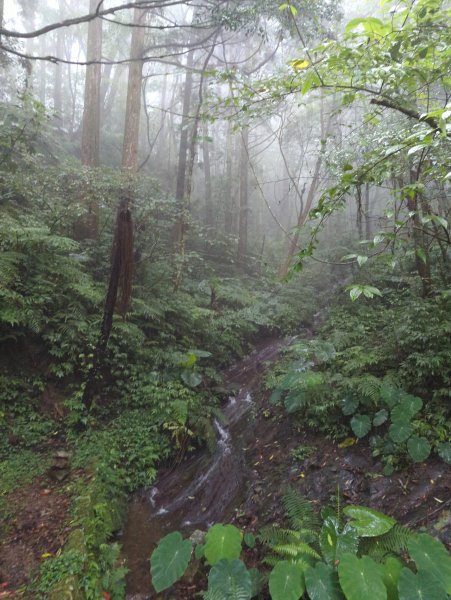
left=122, top=340, right=287, bottom=600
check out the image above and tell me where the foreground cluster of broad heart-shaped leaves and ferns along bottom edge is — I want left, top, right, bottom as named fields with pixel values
left=151, top=490, right=451, bottom=600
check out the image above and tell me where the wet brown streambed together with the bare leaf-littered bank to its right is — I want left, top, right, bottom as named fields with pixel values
left=120, top=340, right=451, bottom=600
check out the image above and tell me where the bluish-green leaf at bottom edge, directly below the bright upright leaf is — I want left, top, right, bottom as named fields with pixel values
left=208, top=560, right=252, bottom=600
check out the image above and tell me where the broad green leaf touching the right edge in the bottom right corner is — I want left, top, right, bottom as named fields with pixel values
left=407, top=533, right=451, bottom=594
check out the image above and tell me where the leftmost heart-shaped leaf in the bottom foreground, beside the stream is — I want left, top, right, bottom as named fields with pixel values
left=150, top=531, right=192, bottom=592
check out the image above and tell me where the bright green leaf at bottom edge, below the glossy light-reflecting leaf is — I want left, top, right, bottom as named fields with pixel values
left=338, top=554, right=387, bottom=600
